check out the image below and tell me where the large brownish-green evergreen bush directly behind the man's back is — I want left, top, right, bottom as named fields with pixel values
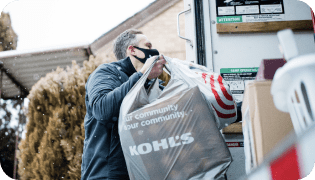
left=18, top=56, right=106, bottom=180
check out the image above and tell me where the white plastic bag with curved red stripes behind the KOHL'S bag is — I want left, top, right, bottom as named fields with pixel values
left=165, top=57, right=237, bottom=129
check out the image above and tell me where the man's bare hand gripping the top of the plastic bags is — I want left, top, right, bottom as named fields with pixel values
left=140, top=55, right=166, bottom=79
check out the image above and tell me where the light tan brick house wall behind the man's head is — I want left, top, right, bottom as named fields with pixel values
left=97, top=1, right=186, bottom=62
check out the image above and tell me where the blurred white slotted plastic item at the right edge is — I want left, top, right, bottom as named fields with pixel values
left=271, top=30, right=315, bottom=134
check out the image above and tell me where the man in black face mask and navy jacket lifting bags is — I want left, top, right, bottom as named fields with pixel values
left=81, top=29, right=165, bottom=180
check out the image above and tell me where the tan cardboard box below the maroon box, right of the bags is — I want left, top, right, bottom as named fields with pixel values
left=242, top=81, right=293, bottom=165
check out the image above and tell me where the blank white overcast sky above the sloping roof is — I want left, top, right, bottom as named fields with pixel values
left=2, top=0, right=155, bottom=50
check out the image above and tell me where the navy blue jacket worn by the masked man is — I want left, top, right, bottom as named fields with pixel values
left=81, top=58, right=143, bottom=180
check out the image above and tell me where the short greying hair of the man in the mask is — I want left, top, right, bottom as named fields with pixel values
left=113, top=29, right=143, bottom=60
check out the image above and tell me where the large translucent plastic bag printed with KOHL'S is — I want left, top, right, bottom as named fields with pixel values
left=118, top=59, right=232, bottom=180
